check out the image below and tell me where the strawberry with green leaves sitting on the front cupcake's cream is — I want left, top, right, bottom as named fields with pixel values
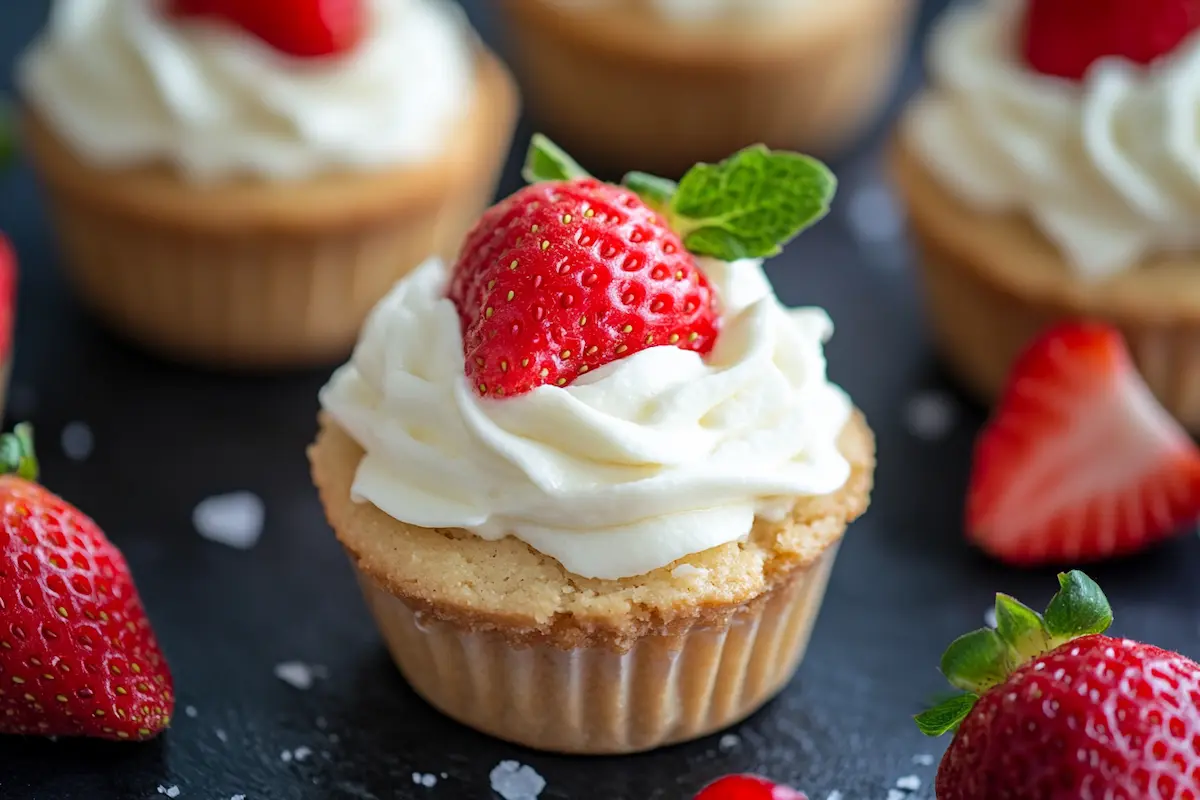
left=448, top=137, right=833, bottom=397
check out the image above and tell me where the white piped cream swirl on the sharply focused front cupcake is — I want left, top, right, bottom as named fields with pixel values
left=320, top=260, right=851, bottom=578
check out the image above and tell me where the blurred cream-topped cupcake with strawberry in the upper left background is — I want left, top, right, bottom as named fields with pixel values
left=17, top=0, right=516, bottom=367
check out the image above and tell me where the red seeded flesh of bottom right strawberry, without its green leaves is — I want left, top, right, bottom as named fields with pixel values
left=937, top=634, right=1200, bottom=800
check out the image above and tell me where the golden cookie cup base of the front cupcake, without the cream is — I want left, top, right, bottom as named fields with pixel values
left=310, top=414, right=874, bottom=754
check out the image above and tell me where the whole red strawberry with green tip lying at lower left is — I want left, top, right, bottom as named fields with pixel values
left=0, top=426, right=175, bottom=740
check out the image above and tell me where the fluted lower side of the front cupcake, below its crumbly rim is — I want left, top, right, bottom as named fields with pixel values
left=352, top=543, right=838, bottom=754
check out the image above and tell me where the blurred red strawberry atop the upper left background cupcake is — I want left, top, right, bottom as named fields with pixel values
left=169, top=0, right=366, bottom=59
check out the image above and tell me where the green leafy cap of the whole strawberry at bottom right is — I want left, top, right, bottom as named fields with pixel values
left=914, top=570, right=1112, bottom=736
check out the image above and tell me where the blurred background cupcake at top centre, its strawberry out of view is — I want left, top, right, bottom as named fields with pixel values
left=502, top=0, right=917, bottom=175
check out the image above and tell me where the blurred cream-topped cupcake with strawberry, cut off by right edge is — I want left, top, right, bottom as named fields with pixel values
left=892, top=0, right=1200, bottom=431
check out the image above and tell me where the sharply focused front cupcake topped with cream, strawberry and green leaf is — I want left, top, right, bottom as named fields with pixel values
left=310, top=137, right=874, bottom=753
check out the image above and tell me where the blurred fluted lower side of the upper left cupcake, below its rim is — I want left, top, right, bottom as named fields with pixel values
left=42, top=190, right=492, bottom=367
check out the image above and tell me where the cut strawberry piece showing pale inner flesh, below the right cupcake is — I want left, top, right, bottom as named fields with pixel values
left=966, top=321, right=1200, bottom=565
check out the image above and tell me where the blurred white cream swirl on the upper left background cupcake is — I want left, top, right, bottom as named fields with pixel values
left=17, top=0, right=474, bottom=180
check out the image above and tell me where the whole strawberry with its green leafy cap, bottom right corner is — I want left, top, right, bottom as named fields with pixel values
left=917, top=571, right=1200, bottom=800
